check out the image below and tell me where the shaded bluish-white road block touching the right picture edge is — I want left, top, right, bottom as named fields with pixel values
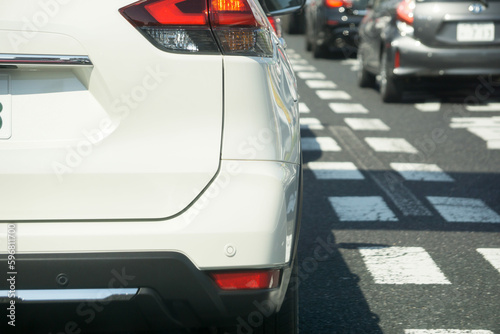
left=427, top=196, right=500, bottom=223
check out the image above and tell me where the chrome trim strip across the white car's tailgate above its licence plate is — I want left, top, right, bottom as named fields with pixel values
left=0, top=53, right=93, bottom=68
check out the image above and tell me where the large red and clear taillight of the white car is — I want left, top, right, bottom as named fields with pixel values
left=120, top=0, right=272, bottom=57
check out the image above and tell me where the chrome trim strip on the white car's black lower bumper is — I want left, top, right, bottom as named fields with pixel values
left=0, top=288, right=139, bottom=303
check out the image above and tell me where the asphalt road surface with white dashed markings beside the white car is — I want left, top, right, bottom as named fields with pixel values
left=286, top=35, right=500, bottom=334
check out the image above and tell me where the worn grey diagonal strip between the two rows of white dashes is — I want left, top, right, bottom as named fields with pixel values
left=329, top=126, right=432, bottom=216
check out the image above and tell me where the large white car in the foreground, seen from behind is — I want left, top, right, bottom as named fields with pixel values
left=0, top=0, right=302, bottom=334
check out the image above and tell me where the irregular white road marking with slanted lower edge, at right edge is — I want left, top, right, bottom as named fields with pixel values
left=450, top=117, right=500, bottom=150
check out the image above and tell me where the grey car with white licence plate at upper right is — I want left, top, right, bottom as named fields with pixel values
left=358, top=0, right=500, bottom=102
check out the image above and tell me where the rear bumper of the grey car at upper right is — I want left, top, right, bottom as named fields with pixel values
left=391, top=37, right=500, bottom=77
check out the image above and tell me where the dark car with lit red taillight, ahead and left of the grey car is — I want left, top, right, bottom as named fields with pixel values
left=305, top=0, right=368, bottom=58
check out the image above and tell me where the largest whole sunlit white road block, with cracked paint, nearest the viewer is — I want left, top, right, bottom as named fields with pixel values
left=359, top=247, right=451, bottom=284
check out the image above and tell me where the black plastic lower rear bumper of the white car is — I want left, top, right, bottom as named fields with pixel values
left=0, top=252, right=291, bottom=333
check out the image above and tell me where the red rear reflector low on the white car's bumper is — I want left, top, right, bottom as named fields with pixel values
left=210, top=270, right=280, bottom=290
